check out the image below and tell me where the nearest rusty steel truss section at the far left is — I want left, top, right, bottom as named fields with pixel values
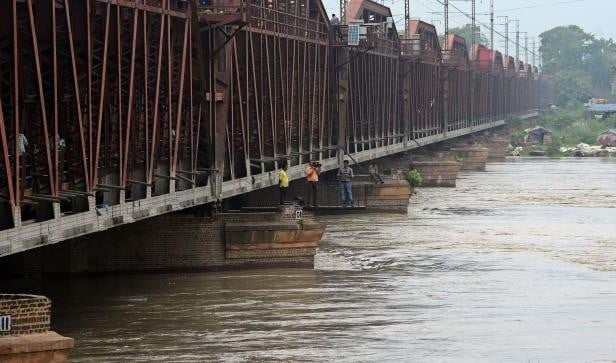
left=0, top=0, right=202, bottom=225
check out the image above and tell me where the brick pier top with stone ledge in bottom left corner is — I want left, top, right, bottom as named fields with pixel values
left=0, top=294, right=75, bottom=363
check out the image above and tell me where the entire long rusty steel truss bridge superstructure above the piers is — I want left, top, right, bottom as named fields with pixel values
left=0, top=0, right=542, bottom=257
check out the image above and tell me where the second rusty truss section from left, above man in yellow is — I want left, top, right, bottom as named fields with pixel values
left=199, top=0, right=338, bottom=180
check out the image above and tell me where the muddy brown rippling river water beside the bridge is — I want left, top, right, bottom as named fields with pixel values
left=1, top=159, right=616, bottom=362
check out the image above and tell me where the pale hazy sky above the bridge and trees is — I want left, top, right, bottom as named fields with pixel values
left=323, top=0, right=616, bottom=54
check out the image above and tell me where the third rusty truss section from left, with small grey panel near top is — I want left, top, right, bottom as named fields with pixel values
left=340, top=0, right=405, bottom=153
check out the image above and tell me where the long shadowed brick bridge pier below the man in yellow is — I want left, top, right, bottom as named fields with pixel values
left=0, top=204, right=325, bottom=274
